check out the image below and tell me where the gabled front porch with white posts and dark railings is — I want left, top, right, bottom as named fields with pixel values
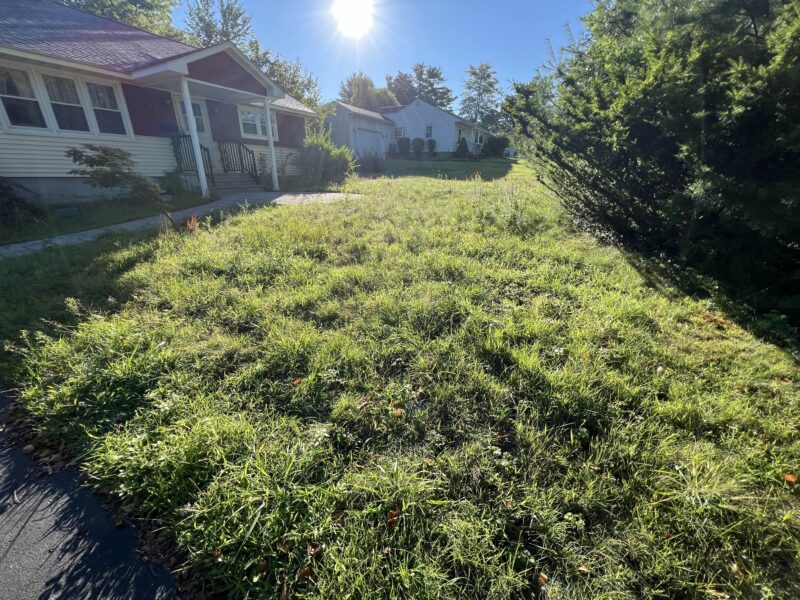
left=129, top=43, right=313, bottom=196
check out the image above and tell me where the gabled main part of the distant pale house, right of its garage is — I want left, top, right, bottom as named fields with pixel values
left=381, top=98, right=490, bottom=154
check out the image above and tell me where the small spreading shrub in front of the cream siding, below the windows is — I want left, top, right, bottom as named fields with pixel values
left=66, top=144, right=166, bottom=209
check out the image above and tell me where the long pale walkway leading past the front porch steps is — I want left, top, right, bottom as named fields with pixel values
left=0, top=192, right=357, bottom=258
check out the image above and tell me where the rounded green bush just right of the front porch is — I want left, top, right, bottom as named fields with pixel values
left=296, top=132, right=356, bottom=190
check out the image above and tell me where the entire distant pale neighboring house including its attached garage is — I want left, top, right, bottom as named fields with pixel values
left=329, top=98, right=490, bottom=157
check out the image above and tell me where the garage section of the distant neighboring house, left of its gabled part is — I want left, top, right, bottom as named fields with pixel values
left=329, top=102, right=394, bottom=158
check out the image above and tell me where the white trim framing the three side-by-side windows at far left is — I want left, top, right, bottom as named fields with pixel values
left=0, top=60, right=135, bottom=140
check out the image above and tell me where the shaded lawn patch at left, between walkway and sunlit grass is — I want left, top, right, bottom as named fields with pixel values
left=0, top=231, right=156, bottom=383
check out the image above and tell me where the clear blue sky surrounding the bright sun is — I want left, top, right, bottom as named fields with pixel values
left=176, top=0, right=592, bottom=105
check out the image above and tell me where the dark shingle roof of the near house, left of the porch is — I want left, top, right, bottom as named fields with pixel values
left=0, top=0, right=196, bottom=72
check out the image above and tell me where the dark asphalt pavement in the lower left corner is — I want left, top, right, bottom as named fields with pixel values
left=0, top=395, right=176, bottom=600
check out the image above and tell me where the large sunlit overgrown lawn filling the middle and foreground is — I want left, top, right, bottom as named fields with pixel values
left=7, top=165, right=800, bottom=599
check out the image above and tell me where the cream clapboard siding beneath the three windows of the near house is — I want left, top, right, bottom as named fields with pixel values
left=0, top=131, right=176, bottom=177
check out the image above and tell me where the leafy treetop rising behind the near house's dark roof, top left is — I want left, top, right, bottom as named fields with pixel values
left=62, top=0, right=189, bottom=41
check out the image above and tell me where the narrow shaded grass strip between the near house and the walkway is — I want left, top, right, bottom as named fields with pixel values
left=0, top=195, right=205, bottom=245
